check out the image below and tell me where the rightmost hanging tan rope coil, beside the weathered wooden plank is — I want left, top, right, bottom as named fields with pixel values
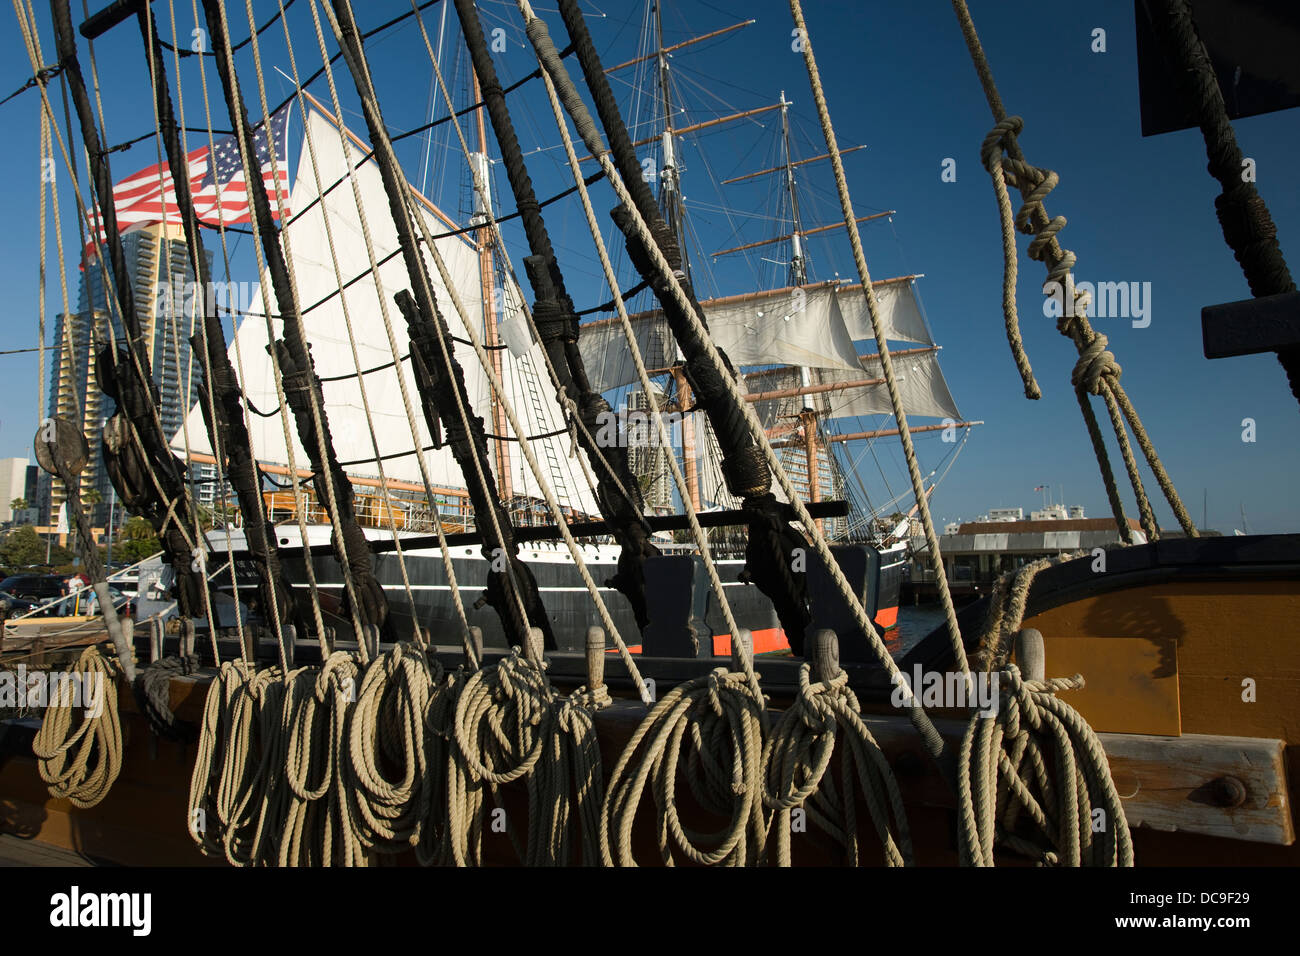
left=957, top=665, right=1134, bottom=866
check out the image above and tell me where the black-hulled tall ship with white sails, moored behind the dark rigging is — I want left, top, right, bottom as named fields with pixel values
left=172, top=3, right=972, bottom=653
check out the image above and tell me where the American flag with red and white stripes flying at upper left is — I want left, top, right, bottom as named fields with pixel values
left=85, top=104, right=291, bottom=261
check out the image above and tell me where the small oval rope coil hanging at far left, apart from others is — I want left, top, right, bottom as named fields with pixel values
left=31, top=646, right=122, bottom=809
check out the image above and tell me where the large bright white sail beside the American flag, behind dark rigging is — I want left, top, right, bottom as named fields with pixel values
left=173, top=109, right=595, bottom=514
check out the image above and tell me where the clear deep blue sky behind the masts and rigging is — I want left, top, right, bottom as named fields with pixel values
left=0, top=0, right=1300, bottom=533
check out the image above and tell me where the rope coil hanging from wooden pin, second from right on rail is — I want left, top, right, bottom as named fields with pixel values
left=763, top=630, right=913, bottom=866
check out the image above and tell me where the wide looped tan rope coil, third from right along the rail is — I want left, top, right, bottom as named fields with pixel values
left=601, top=667, right=767, bottom=866
